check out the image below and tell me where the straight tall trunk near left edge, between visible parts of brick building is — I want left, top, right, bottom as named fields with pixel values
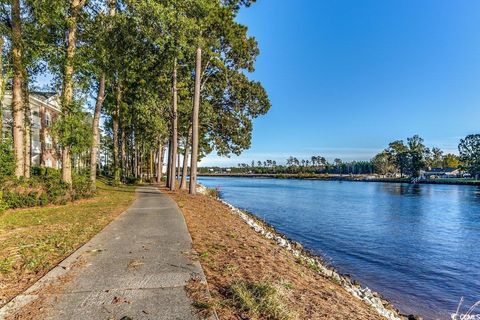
left=11, top=0, right=25, bottom=178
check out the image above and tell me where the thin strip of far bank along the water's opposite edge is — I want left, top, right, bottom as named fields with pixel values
left=198, top=173, right=480, bottom=186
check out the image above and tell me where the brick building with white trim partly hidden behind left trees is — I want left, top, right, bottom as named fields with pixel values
left=1, top=91, right=61, bottom=168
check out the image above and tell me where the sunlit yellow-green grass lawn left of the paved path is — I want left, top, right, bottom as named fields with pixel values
left=0, top=182, right=135, bottom=307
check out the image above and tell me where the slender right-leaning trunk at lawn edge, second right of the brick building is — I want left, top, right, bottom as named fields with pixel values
left=90, top=73, right=105, bottom=189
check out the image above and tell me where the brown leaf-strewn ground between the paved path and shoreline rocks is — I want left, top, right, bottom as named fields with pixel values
left=163, top=189, right=382, bottom=320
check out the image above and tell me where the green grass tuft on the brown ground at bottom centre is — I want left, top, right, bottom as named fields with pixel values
left=230, top=281, right=297, bottom=320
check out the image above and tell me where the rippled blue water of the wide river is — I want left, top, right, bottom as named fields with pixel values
left=200, top=177, right=480, bottom=319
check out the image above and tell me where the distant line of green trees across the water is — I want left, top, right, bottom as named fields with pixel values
left=200, top=134, right=480, bottom=177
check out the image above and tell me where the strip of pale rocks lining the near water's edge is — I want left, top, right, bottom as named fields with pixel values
left=197, top=185, right=414, bottom=320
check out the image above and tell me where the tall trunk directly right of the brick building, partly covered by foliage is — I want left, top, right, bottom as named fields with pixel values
left=62, top=0, right=86, bottom=184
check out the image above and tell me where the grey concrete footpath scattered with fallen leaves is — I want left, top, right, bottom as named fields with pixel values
left=0, top=187, right=212, bottom=320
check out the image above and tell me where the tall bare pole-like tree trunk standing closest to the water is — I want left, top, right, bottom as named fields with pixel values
left=190, top=47, right=202, bottom=195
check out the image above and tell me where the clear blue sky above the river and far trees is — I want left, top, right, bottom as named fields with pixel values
left=201, top=0, right=480, bottom=165
